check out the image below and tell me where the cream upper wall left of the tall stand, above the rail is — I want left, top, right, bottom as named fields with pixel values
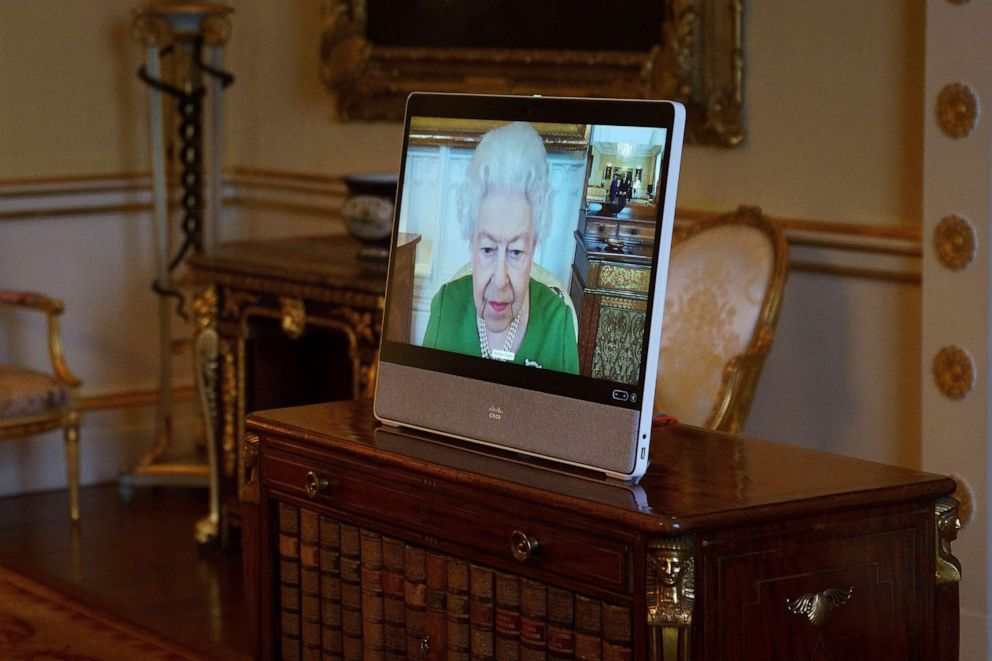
left=0, top=0, right=148, bottom=180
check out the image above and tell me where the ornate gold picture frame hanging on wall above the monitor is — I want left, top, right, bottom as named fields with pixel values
left=320, top=0, right=744, bottom=147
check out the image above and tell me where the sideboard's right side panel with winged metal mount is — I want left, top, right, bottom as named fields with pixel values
left=704, top=516, right=932, bottom=661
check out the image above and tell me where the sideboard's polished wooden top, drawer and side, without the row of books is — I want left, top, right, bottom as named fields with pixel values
left=244, top=400, right=959, bottom=661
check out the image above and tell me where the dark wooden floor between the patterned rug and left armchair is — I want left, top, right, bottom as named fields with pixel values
left=0, top=484, right=250, bottom=659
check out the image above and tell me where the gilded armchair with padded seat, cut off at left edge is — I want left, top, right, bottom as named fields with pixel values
left=0, top=290, right=82, bottom=522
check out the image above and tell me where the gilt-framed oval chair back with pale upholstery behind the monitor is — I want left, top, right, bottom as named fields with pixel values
left=655, top=207, right=789, bottom=432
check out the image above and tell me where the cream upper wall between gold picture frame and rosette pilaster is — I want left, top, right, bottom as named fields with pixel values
left=679, top=0, right=924, bottom=225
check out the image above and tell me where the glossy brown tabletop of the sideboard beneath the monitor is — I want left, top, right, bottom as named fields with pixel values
left=248, top=400, right=954, bottom=534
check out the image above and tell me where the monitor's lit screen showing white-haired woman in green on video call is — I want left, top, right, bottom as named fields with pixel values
left=382, top=93, right=671, bottom=408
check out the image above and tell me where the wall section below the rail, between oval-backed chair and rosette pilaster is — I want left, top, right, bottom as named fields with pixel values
left=745, top=272, right=921, bottom=466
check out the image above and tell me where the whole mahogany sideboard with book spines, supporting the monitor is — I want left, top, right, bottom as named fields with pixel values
left=243, top=400, right=960, bottom=661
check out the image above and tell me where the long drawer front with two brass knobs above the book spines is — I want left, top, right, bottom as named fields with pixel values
left=262, top=455, right=632, bottom=594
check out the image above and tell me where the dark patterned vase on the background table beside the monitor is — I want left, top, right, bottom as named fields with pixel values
left=341, top=174, right=398, bottom=260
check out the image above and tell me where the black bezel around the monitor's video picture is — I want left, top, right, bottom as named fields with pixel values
left=380, top=93, right=676, bottom=410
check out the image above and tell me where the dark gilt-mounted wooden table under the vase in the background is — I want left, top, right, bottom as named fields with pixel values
left=189, top=235, right=420, bottom=541
